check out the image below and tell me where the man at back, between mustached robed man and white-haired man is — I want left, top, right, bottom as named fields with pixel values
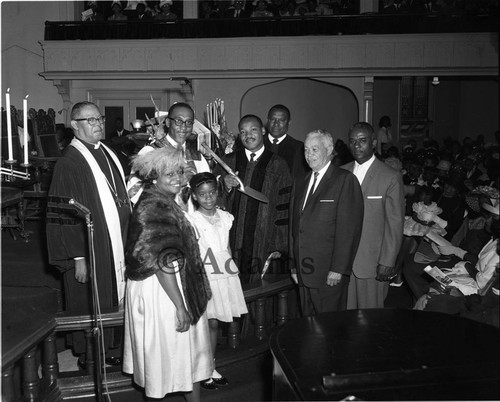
left=264, top=105, right=309, bottom=177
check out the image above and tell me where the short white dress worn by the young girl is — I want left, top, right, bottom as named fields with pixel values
left=189, top=209, right=248, bottom=322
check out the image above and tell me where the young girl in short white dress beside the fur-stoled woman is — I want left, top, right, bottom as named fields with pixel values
left=189, top=173, right=248, bottom=389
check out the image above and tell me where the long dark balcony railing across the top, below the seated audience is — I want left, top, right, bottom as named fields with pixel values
left=45, top=14, right=500, bottom=40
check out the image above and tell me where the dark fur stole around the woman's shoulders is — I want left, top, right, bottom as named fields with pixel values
left=126, top=185, right=212, bottom=324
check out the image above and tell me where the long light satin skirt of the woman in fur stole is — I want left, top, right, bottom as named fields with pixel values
left=123, top=273, right=214, bottom=398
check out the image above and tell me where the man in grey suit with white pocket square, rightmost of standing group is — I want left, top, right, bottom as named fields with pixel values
left=342, top=123, right=404, bottom=309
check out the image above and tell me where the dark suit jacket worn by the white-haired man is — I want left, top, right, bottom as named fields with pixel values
left=289, top=164, right=363, bottom=288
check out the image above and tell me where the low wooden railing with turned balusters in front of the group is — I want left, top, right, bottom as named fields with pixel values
left=2, top=275, right=293, bottom=402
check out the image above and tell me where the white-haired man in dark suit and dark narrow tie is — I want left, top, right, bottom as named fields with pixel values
left=289, top=130, right=363, bottom=316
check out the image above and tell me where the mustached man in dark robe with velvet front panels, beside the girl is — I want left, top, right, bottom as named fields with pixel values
left=214, top=115, right=292, bottom=283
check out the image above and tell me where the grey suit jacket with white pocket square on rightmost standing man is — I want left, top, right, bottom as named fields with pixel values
left=342, top=159, right=405, bottom=278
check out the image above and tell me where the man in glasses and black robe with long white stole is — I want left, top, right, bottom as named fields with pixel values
left=47, top=102, right=131, bottom=365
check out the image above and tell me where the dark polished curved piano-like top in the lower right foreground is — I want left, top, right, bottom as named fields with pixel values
left=270, top=309, right=500, bottom=400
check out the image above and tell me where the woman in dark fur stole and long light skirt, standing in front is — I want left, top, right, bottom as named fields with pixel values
left=123, top=147, right=214, bottom=401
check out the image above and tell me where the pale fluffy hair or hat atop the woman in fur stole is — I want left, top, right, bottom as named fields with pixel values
left=132, top=146, right=190, bottom=180
